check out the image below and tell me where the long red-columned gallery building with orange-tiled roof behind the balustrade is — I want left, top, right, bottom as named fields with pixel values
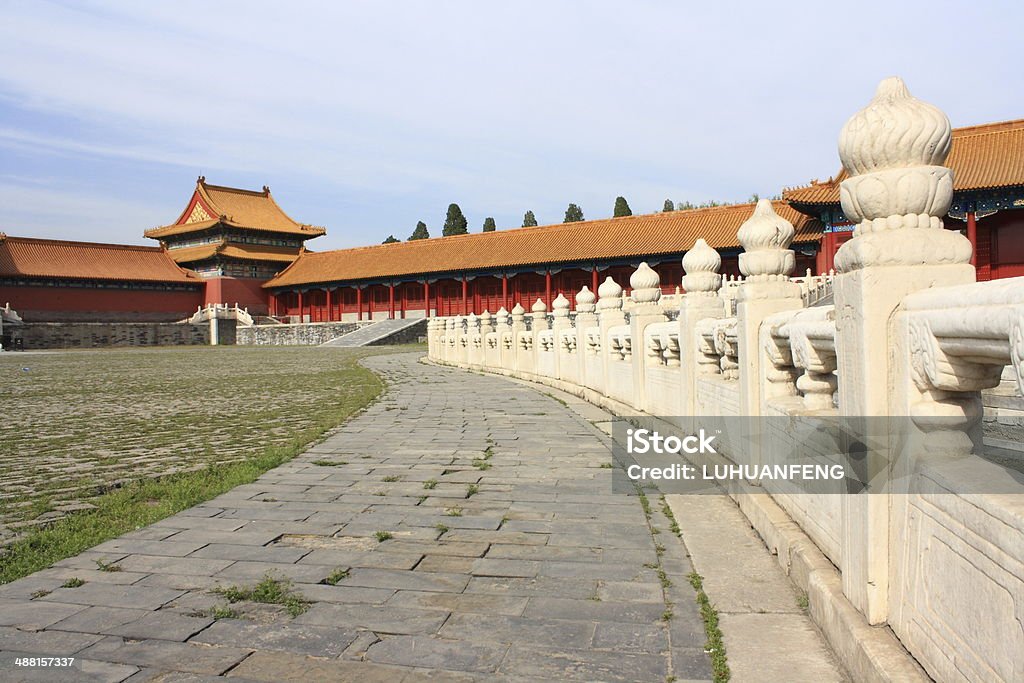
left=264, top=201, right=821, bottom=322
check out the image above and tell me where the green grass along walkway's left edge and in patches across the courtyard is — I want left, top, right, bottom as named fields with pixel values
left=0, top=347, right=400, bottom=584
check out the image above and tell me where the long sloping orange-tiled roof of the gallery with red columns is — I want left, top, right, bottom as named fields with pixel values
left=264, top=201, right=821, bottom=288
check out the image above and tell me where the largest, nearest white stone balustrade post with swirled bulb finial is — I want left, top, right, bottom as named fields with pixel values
left=833, top=78, right=975, bottom=624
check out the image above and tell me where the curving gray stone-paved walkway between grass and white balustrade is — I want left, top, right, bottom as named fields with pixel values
left=0, top=354, right=711, bottom=683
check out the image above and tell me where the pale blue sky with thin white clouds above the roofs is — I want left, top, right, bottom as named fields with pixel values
left=0, top=0, right=1024, bottom=251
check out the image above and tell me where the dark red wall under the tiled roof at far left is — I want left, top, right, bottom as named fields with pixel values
left=0, top=286, right=203, bottom=322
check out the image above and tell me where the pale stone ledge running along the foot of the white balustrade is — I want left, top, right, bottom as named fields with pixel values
left=421, top=356, right=932, bottom=683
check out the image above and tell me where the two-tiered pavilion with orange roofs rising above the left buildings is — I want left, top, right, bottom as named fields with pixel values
left=145, top=176, right=325, bottom=314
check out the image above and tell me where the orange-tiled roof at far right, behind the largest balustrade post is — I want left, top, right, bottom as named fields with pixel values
left=782, top=119, right=1024, bottom=205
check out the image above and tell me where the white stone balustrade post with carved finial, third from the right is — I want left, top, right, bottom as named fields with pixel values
left=678, top=238, right=725, bottom=432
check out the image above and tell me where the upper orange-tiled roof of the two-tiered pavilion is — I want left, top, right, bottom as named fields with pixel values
left=145, top=176, right=326, bottom=240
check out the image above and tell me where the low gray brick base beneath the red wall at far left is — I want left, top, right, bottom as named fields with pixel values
left=18, top=323, right=210, bottom=350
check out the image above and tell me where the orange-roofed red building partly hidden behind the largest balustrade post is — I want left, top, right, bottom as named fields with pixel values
left=782, top=119, right=1024, bottom=281
